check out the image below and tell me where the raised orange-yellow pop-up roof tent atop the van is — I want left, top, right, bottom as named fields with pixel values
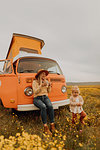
left=6, top=33, right=45, bottom=60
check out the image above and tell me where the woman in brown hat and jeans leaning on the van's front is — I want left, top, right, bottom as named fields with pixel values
left=32, top=69, right=55, bottom=135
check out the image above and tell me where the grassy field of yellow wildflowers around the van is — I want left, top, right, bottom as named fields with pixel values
left=0, top=86, right=100, bottom=150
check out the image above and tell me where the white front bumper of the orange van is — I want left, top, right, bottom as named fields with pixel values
left=17, top=99, right=69, bottom=111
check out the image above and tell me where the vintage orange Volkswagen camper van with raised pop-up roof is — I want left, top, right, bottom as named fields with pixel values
left=0, top=34, right=69, bottom=111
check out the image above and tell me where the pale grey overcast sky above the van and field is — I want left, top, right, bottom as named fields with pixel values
left=0, top=0, right=100, bottom=82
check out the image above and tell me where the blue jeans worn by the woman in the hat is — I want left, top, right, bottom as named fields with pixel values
left=33, top=95, right=54, bottom=124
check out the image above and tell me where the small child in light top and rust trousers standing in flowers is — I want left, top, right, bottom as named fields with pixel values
left=70, top=86, right=86, bottom=124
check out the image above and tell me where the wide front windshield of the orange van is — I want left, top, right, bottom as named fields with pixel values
left=17, top=57, right=62, bottom=74
